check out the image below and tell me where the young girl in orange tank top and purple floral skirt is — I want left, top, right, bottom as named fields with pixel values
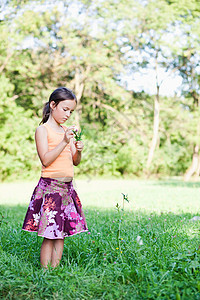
left=22, top=87, right=87, bottom=268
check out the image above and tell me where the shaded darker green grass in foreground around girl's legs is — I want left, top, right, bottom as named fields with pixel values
left=0, top=206, right=200, bottom=299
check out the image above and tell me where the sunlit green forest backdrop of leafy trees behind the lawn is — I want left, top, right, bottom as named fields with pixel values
left=0, top=0, right=200, bottom=181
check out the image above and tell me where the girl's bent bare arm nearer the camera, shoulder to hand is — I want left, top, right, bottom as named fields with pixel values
left=35, top=126, right=73, bottom=167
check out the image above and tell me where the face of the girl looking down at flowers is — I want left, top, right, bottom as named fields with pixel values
left=50, top=100, right=76, bottom=124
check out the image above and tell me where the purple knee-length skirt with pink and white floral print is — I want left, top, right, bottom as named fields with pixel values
left=22, top=177, right=88, bottom=239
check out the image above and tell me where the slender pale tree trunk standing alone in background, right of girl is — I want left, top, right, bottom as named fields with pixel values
left=147, top=85, right=160, bottom=170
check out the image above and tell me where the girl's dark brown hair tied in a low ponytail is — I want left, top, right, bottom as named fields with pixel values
left=40, top=87, right=77, bottom=124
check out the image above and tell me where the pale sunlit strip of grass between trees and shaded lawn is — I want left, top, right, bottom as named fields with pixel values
left=0, top=178, right=200, bottom=213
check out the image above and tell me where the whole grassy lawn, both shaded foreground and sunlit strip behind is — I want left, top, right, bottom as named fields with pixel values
left=0, top=180, right=200, bottom=300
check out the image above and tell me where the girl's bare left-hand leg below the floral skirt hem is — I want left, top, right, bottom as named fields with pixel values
left=40, top=238, right=54, bottom=269
